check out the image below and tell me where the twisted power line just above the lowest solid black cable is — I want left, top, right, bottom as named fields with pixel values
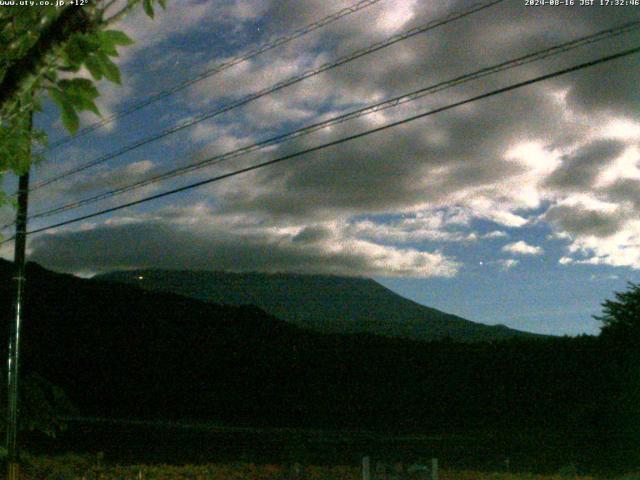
left=21, top=21, right=640, bottom=225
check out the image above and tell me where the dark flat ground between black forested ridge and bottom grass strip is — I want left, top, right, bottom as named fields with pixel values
left=25, top=419, right=623, bottom=475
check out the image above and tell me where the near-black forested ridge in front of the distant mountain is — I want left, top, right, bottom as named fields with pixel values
left=0, top=260, right=608, bottom=450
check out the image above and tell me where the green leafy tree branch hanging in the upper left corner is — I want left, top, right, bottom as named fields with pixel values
left=0, top=0, right=166, bottom=180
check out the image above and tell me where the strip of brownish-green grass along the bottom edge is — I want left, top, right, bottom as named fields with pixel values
left=15, top=455, right=640, bottom=480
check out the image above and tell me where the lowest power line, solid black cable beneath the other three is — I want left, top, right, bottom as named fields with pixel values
left=0, top=46, right=640, bottom=245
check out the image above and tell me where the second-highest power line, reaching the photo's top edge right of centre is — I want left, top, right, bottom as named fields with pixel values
left=31, top=0, right=504, bottom=191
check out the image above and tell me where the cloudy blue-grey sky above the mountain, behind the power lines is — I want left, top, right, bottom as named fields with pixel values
left=0, top=0, right=640, bottom=335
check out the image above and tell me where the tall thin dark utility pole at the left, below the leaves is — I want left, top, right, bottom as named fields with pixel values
left=7, top=113, right=33, bottom=480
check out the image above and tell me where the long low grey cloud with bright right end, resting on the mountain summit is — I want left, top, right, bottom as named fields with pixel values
left=29, top=206, right=460, bottom=277
